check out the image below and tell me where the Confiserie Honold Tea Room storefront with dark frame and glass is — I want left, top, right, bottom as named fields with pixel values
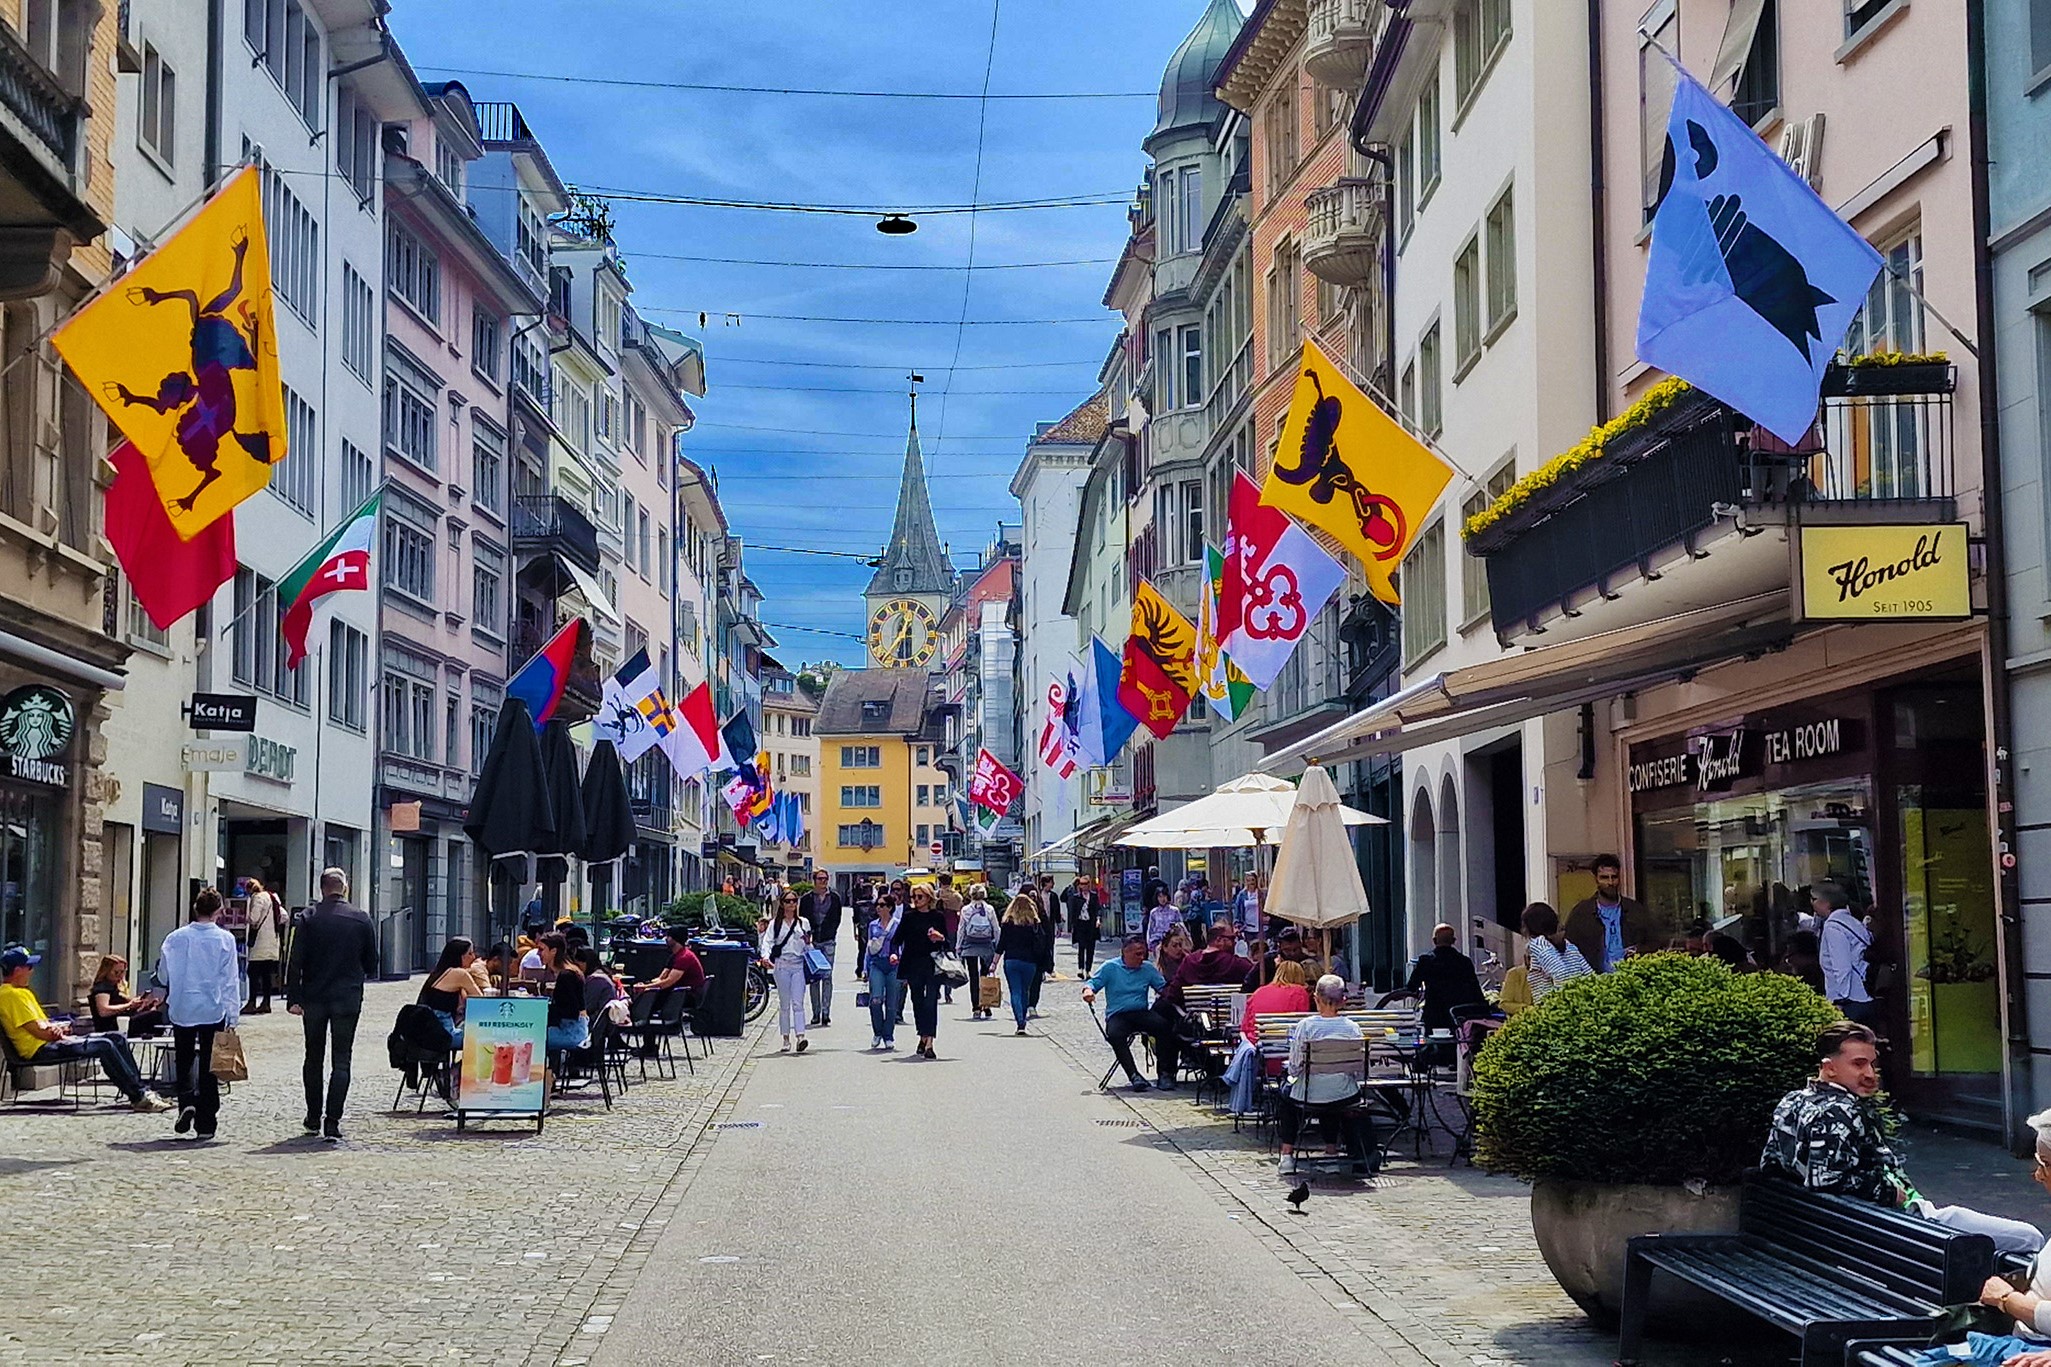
left=1628, top=668, right=2002, bottom=1129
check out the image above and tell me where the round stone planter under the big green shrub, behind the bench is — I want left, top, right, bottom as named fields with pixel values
left=1532, top=1178, right=1737, bottom=1334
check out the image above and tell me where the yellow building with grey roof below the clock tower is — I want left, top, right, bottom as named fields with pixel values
left=812, top=670, right=946, bottom=892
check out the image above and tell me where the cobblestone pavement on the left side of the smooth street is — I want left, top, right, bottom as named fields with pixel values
left=0, top=982, right=762, bottom=1367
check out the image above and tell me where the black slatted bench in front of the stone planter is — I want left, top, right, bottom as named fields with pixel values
left=1618, top=1172, right=1994, bottom=1367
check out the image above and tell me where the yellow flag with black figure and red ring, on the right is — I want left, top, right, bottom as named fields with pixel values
left=1261, top=340, right=1452, bottom=605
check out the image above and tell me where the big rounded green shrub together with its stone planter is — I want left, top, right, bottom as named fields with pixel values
left=1473, top=953, right=1838, bottom=1324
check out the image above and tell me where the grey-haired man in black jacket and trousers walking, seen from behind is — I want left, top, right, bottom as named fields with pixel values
left=285, top=869, right=377, bottom=1144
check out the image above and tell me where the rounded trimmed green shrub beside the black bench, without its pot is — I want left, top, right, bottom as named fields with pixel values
left=1473, top=953, right=1838, bottom=1185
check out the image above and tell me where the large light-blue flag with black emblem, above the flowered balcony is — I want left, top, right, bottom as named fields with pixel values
left=1639, top=68, right=1881, bottom=445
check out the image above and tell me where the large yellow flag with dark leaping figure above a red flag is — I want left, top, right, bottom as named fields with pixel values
left=49, top=166, right=285, bottom=541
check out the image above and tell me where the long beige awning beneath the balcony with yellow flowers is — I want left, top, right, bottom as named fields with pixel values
left=1261, top=590, right=1797, bottom=771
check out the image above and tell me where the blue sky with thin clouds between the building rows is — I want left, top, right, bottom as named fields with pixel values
left=392, top=0, right=1204, bottom=664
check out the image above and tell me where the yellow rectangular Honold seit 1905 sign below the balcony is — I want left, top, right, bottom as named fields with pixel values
left=1797, top=523, right=1973, bottom=621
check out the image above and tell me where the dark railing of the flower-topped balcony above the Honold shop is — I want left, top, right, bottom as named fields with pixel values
left=1469, top=367, right=1957, bottom=639
